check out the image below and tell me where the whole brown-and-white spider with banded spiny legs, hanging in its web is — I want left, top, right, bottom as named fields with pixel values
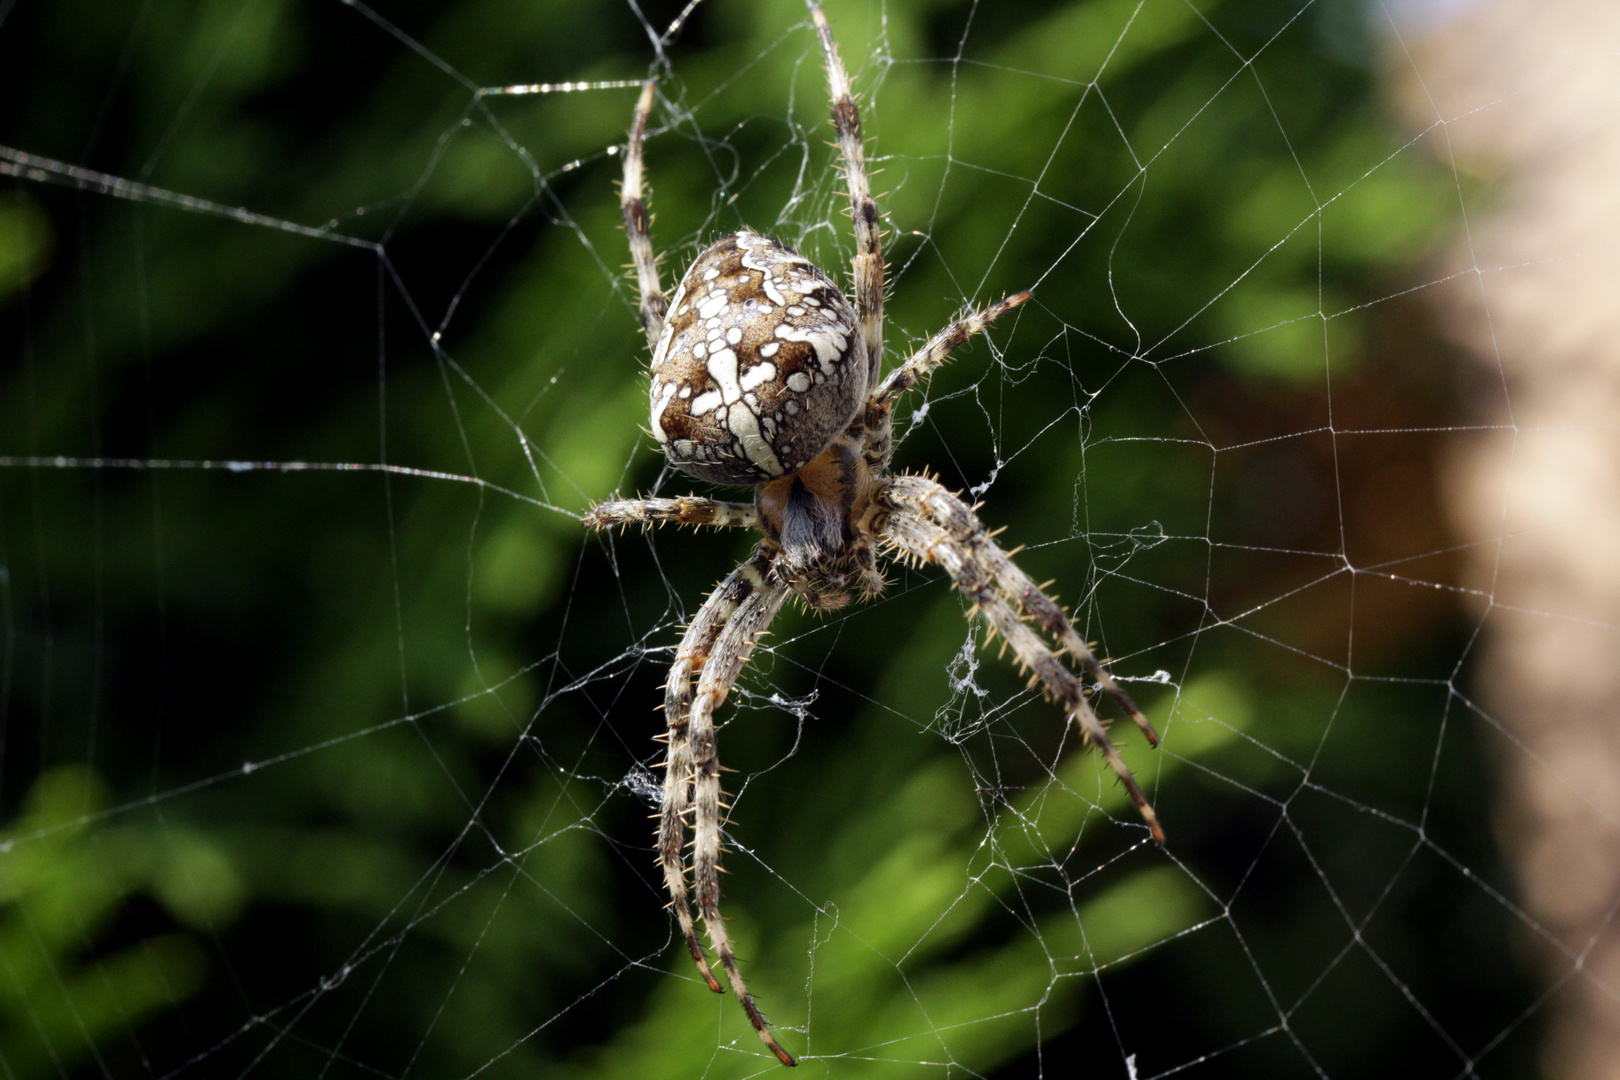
left=583, top=0, right=1165, bottom=1065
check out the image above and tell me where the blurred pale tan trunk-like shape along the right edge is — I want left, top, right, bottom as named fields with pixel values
left=1390, top=0, right=1620, bottom=1080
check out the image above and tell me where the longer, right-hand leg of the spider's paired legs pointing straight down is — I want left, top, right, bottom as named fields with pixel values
left=687, top=563, right=797, bottom=1065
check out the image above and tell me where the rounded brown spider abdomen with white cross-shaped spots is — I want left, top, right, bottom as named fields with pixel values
left=651, top=232, right=867, bottom=484
